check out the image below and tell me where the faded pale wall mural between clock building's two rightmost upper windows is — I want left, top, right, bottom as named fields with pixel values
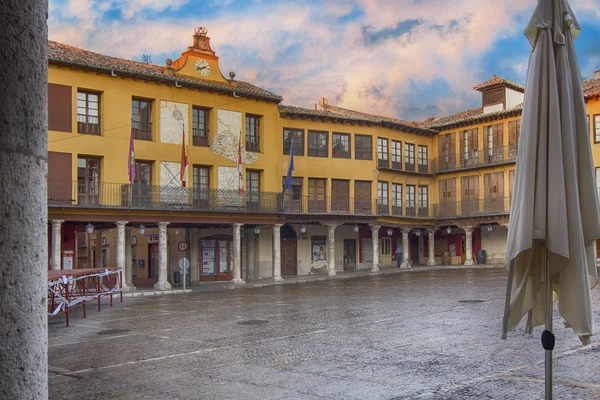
left=211, top=110, right=258, bottom=163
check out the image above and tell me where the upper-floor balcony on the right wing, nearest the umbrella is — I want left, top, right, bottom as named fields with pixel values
left=432, top=144, right=517, bottom=173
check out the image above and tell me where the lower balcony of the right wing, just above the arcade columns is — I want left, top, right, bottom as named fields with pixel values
left=434, top=197, right=511, bottom=219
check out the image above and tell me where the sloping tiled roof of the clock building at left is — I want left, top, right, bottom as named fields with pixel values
left=48, top=41, right=282, bottom=103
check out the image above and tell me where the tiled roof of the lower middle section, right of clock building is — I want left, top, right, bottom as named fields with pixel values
left=279, top=104, right=437, bottom=136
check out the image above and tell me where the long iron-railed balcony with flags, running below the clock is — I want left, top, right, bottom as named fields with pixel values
left=48, top=180, right=434, bottom=218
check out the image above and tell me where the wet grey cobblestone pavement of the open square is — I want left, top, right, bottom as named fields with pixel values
left=48, top=269, right=600, bottom=400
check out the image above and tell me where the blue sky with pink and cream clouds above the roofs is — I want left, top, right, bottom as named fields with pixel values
left=48, top=0, right=600, bottom=121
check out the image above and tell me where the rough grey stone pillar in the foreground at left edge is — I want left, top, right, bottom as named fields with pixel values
left=0, top=0, right=48, bottom=400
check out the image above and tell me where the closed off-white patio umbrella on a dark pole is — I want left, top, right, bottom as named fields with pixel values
left=503, top=0, right=600, bottom=398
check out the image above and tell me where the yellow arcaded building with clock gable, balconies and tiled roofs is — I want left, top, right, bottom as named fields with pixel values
left=48, top=28, right=600, bottom=289
